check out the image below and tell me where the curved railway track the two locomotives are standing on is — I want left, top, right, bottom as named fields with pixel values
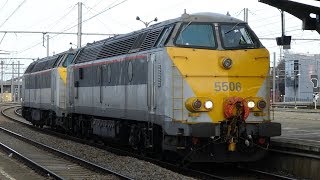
left=2, top=106, right=294, bottom=180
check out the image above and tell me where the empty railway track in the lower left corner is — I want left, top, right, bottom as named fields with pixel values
left=0, top=106, right=132, bottom=179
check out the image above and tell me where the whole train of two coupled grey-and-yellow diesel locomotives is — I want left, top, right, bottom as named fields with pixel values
left=22, top=13, right=281, bottom=162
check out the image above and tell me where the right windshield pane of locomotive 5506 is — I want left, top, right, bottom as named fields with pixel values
left=220, top=24, right=258, bottom=49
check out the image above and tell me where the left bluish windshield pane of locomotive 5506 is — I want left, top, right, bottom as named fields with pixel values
left=175, top=22, right=216, bottom=49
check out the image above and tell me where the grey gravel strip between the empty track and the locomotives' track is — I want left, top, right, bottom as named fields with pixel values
left=0, top=112, right=193, bottom=180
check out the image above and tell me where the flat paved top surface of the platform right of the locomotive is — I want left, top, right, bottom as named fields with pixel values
left=271, top=108, right=320, bottom=153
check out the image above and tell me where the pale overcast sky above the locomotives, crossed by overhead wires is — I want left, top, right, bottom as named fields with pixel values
left=0, top=0, right=320, bottom=73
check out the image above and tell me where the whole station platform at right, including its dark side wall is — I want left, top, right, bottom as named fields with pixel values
left=256, top=108, right=320, bottom=179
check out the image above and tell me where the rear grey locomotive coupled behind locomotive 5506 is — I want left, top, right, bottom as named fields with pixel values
left=22, top=50, right=77, bottom=127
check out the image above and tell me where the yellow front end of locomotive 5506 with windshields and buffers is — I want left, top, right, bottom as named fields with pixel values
left=167, top=13, right=281, bottom=162
